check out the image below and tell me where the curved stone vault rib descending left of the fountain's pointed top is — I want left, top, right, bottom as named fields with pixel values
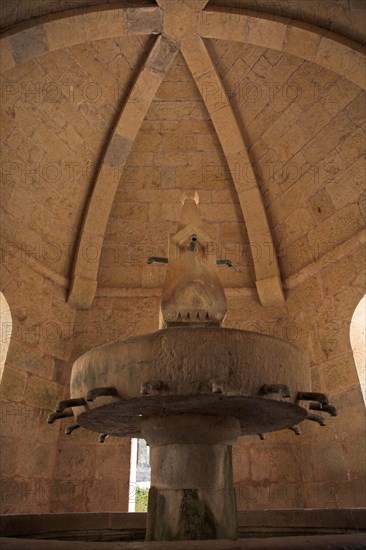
left=68, top=36, right=178, bottom=308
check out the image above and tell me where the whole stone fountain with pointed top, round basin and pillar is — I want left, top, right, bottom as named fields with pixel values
left=48, top=193, right=337, bottom=540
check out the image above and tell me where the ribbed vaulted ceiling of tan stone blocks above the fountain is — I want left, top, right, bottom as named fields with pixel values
left=0, top=0, right=366, bottom=307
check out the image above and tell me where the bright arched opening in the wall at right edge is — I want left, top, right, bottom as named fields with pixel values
left=350, top=295, right=366, bottom=404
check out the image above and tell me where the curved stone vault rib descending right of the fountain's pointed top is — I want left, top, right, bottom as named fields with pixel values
left=181, top=36, right=284, bottom=307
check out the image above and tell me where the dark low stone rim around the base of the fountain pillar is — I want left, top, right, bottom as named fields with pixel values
left=0, top=508, right=366, bottom=550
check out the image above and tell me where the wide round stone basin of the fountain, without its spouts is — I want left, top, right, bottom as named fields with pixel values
left=70, top=327, right=311, bottom=437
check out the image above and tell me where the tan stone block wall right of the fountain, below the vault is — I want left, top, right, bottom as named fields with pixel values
left=226, top=235, right=365, bottom=509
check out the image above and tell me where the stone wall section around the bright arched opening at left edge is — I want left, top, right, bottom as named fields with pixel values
left=0, top=252, right=75, bottom=513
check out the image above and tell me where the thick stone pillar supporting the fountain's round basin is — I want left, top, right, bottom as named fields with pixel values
left=142, top=414, right=240, bottom=540
